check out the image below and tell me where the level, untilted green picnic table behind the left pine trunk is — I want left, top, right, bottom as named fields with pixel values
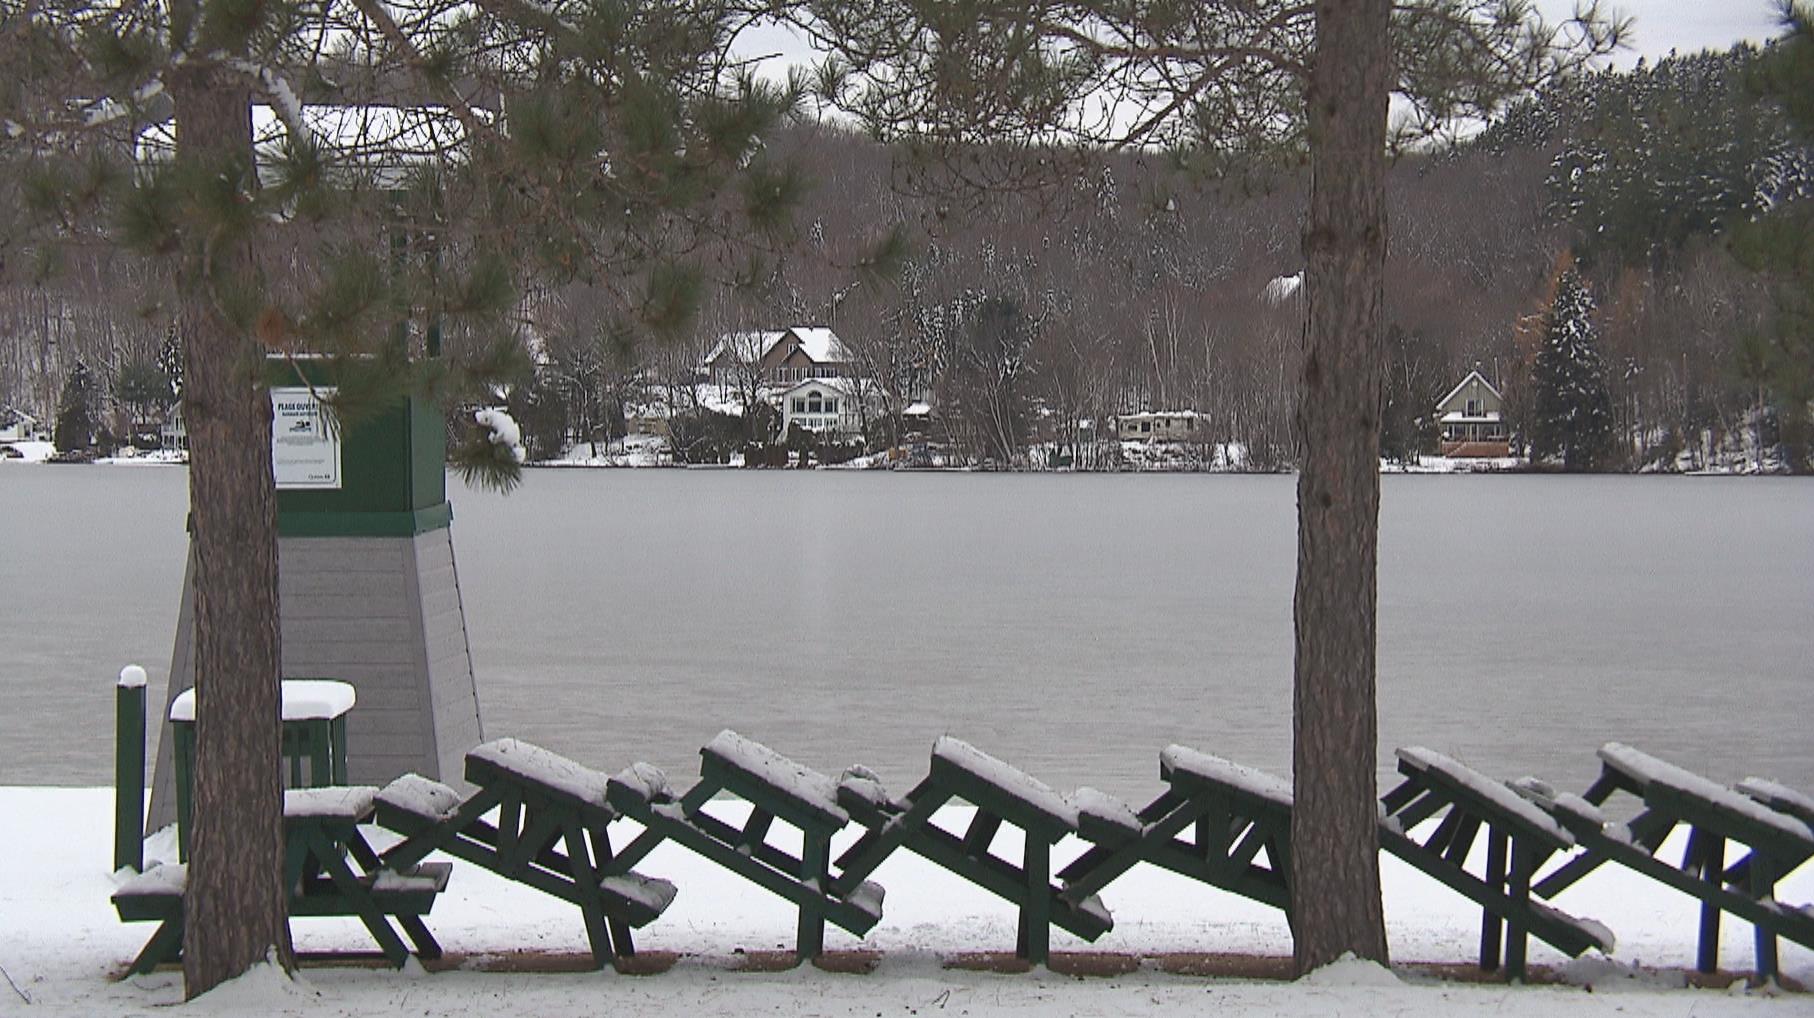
left=112, top=786, right=452, bottom=973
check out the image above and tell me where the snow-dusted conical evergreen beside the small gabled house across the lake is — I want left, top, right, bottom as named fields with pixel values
left=1531, top=267, right=1613, bottom=470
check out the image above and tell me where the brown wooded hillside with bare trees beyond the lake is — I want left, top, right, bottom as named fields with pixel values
left=0, top=39, right=1814, bottom=470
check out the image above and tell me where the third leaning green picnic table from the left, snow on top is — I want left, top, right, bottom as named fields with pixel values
left=833, top=737, right=1114, bottom=965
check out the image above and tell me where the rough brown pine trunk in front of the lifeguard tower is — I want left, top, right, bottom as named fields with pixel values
left=167, top=62, right=290, bottom=998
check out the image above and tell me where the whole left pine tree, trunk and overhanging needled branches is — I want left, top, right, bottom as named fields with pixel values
left=0, top=0, right=802, bottom=996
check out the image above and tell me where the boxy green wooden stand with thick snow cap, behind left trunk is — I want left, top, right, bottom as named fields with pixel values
left=171, top=679, right=357, bottom=860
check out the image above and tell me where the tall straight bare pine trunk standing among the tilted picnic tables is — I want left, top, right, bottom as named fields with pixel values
left=1292, top=0, right=1391, bottom=973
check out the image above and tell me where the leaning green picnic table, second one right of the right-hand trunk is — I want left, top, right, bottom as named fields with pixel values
left=1517, top=742, right=1814, bottom=978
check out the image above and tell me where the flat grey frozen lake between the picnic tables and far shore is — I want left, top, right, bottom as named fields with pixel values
left=0, top=465, right=1814, bottom=798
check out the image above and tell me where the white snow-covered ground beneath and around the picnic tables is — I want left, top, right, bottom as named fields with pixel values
left=0, top=788, right=1814, bottom=1018
